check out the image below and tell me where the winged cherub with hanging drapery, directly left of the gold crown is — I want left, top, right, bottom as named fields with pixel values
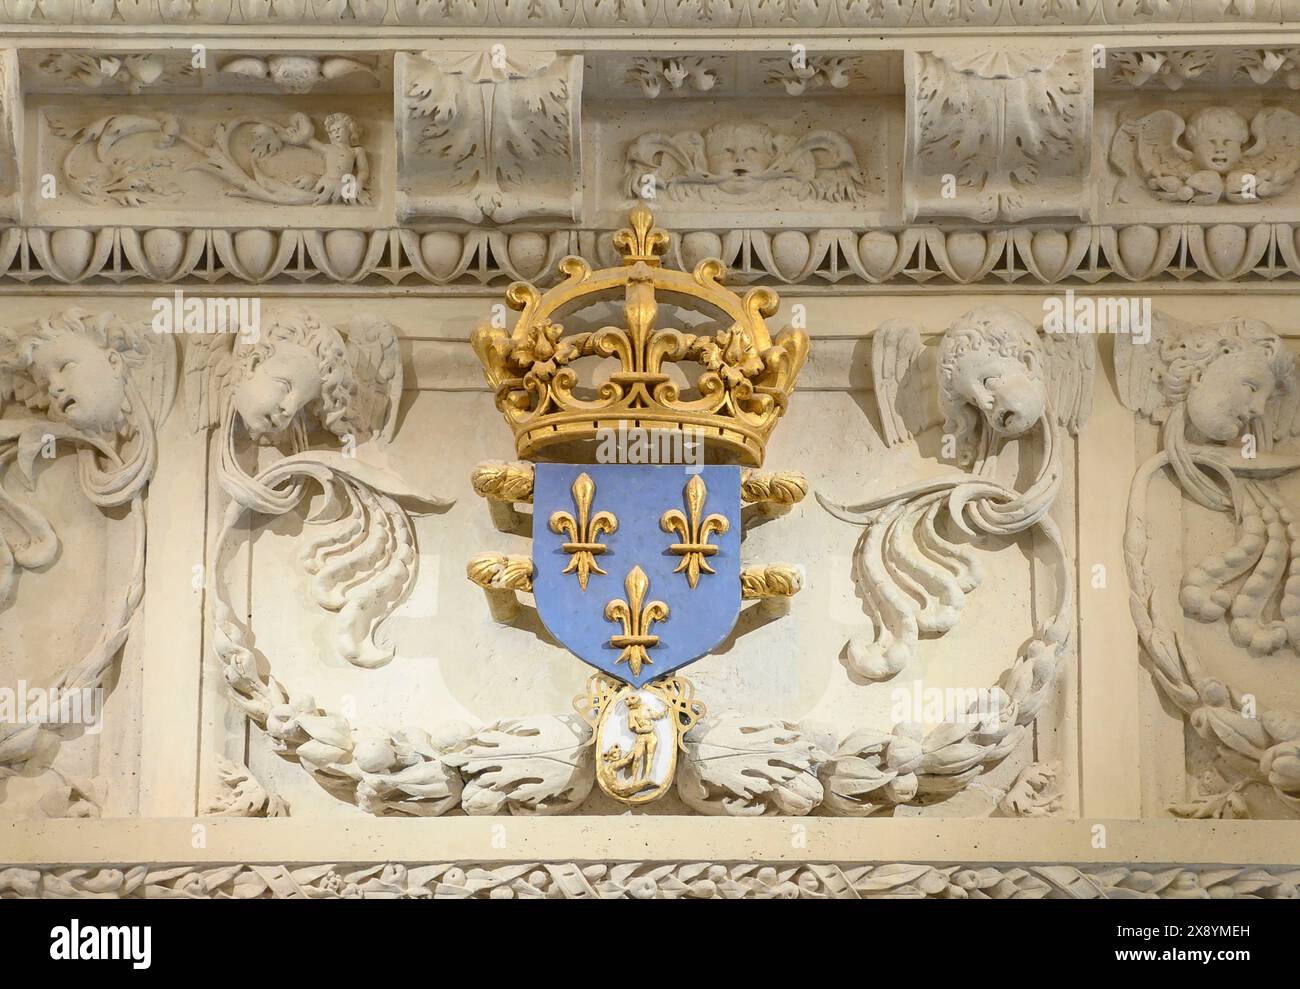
left=186, top=308, right=441, bottom=670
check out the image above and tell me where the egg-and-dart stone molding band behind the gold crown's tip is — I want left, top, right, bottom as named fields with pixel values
left=0, top=222, right=1300, bottom=291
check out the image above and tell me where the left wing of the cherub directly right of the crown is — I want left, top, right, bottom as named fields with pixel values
left=871, top=320, right=943, bottom=447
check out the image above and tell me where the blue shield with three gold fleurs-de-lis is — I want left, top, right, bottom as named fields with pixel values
left=533, top=464, right=740, bottom=686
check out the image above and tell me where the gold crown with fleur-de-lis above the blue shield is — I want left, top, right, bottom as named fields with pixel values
left=473, top=205, right=809, bottom=467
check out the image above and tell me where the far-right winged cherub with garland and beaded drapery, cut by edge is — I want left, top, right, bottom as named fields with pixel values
left=1115, top=313, right=1300, bottom=812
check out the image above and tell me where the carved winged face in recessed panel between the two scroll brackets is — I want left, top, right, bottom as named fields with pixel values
left=624, top=121, right=867, bottom=203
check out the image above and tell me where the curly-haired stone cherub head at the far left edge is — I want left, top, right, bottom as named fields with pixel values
left=0, top=308, right=148, bottom=435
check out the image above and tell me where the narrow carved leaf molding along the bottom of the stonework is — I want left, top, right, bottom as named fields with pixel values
left=0, top=862, right=1300, bottom=899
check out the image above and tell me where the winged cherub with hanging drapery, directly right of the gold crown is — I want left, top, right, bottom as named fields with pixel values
left=818, top=305, right=1096, bottom=691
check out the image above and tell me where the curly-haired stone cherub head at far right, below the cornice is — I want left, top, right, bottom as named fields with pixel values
left=1162, top=324, right=1295, bottom=443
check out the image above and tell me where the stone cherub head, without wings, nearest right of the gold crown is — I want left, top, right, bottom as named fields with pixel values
left=939, top=305, right=1047, bottom=439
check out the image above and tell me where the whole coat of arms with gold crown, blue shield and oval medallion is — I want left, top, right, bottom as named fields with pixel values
left=468, top=205, right=809, bottom=803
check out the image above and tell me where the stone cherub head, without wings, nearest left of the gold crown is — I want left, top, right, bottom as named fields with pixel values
left=233, top=309, right=358, bottom=439
